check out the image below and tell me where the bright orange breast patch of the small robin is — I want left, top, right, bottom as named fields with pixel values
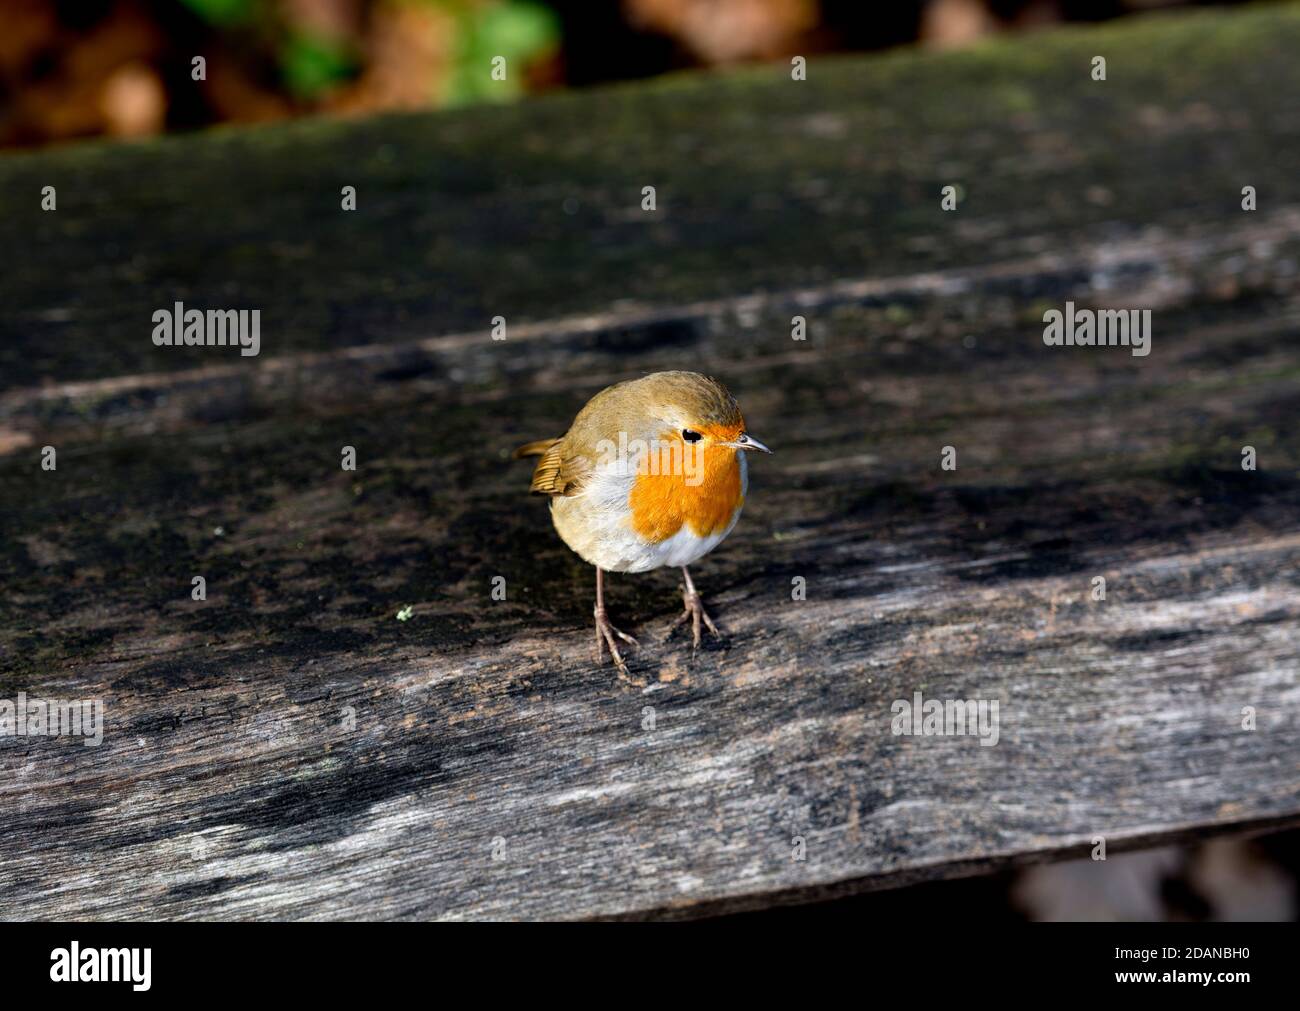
left=628, top=434, right=744, bottom=543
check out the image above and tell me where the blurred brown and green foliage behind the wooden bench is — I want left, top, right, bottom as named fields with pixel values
left=0, top=0, right=1263, bottom=147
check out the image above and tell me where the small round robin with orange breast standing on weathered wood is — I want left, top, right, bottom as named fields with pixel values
left=515, top=372, right=772, bottom=676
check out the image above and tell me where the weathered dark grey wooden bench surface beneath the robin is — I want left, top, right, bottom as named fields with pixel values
left=0, top=8, right=1300, bottom=919
